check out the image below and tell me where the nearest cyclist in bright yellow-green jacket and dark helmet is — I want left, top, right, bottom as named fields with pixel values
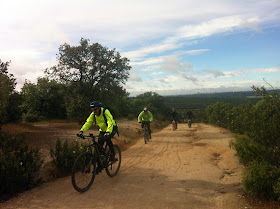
left=77, top=101, right=118, bottom=161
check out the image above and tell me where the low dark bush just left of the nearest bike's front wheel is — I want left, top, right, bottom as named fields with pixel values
left=50, top=139, right=87, bottom=177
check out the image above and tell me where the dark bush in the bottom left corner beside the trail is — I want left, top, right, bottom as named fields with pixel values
left=0, top=133, right=43, bottom=194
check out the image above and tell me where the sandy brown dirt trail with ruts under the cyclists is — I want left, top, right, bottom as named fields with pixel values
left=0, top=124, right=251, bottom=209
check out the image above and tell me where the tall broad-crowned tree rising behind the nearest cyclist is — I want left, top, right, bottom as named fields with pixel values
left=45, top=38, right=131, bottom=122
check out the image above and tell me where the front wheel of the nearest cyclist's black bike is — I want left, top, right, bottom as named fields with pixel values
left=72, top=152, right=96, bottom=192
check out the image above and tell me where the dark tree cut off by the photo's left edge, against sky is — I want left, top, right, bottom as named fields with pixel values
left=0, top=59, right=16, bottom=125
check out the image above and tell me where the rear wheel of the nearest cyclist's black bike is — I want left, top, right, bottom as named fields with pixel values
left=106, top=144, right=122, bottom=177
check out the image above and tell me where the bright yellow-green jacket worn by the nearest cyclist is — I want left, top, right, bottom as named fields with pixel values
left=81, top=107, right=117, bottom=134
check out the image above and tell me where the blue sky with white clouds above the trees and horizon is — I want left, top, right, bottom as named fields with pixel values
left=0, top=0, right=280, bottom=96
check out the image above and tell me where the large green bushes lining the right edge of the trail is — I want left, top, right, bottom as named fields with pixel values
left=207, top=87, right=280, bottom=199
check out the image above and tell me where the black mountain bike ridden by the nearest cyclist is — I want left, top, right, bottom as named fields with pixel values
left=72, top=134, right=121, bottom=192
